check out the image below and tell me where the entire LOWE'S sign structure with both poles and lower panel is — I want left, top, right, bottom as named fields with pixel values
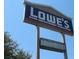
left=24, top=2, right=73, bottom=59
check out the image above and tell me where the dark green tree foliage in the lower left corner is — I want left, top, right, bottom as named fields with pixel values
left=4, top=32, right=31, bottom=59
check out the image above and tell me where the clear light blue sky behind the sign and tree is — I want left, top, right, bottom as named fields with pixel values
left=4, top=0, right=74, bottom=59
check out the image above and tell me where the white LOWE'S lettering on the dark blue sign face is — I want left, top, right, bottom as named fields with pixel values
left=30, top=7, right=69, bottom=30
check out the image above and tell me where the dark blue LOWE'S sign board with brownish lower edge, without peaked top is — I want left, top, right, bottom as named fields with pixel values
left=24, top=5, right=73, bottom=35
